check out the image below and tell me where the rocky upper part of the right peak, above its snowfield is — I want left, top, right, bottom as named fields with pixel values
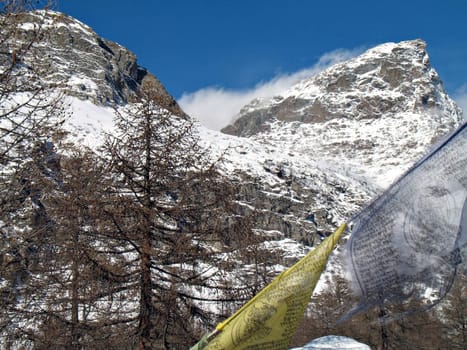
left=222, top=40, right=461, bottom=136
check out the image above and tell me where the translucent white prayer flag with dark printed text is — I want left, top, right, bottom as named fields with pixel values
left=344, top=123, right=467, bottom=318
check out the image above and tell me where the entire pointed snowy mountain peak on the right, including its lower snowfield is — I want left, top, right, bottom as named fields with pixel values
left=218, top=40, right=462, bottom=192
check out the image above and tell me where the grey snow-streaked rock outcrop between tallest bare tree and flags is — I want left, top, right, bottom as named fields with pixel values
left=230, top=169, right=369, bottom=246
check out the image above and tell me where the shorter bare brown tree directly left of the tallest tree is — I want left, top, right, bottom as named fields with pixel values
left=35, top=150, right=134, bottom=349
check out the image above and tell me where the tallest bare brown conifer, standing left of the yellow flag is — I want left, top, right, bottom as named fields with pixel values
left=104, top=82, right=243, bottom=349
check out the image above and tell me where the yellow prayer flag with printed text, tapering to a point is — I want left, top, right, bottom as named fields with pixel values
left=191, top=225, right=345, bottom=350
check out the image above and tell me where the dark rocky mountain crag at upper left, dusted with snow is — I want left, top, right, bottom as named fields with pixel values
left=5, top=11, right=185, bottom=116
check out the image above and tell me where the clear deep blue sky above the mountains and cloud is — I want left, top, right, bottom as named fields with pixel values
left=58, top=0, right=467, bottom=128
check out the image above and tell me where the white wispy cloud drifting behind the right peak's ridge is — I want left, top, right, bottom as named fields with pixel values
left=178, top=49, right=361, bottom=130
